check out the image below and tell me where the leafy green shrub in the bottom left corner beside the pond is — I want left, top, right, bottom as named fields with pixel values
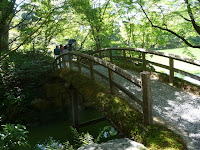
left=0, top=124, right=30, bottom=150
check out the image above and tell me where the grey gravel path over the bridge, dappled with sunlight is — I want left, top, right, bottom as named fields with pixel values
left=71, top=65, right=200, bottom=150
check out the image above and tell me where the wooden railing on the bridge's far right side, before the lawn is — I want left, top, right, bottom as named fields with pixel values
left=89, top=48, right=200, bottom=83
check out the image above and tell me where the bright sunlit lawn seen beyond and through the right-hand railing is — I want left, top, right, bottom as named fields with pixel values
left=147, top=48, right=200, bottom=74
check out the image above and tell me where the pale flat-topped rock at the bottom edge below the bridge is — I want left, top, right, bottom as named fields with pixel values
left=78, top=138, right=147, bottom=150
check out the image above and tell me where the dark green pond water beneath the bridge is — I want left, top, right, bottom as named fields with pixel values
left=28, top=108, right=119, bottom=147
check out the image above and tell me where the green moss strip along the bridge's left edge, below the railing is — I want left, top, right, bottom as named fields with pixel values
left=60, top=70, right=186, bottom=150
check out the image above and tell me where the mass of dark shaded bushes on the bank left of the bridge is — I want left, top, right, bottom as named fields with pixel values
left=0, top=51, right=53, bottom=121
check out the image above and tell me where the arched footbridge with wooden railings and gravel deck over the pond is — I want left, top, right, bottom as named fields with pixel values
left=54, top=48, right=200, bottom=149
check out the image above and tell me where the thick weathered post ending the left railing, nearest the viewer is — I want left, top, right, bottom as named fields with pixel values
left=140, top=71, right=153, bottom=125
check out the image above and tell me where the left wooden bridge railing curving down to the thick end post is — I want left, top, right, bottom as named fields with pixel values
left=53, top=51, right=153, bottom=125
